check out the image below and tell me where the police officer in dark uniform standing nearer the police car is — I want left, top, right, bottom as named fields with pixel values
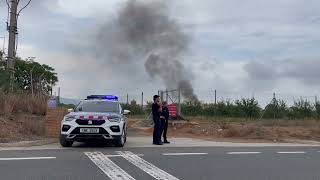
left=152, top=95, right=162, bottom=145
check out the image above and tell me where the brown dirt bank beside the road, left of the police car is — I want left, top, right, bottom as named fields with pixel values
left=0, top=113, right=45, bottom=143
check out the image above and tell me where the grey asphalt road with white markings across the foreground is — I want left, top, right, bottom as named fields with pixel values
left=0, top=147, right=320, bottom=180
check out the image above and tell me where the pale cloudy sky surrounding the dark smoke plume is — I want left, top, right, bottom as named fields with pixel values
left=0, top=0, right=320, bottom=103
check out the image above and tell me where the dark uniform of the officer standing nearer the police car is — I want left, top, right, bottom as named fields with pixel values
left=152, top=103, right=161, bottom=144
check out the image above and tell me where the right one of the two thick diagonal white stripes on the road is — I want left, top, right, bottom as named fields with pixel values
left=118, top=151, right=179, bottom=180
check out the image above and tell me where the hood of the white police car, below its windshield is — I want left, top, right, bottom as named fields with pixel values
left=68, top=112, right=121, bottom=119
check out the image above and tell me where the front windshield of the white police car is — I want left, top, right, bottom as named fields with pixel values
left=75, top=101, right=120, bottom=113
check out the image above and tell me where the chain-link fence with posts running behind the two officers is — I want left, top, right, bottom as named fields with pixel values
left=120, top=90, right=320, bottom=119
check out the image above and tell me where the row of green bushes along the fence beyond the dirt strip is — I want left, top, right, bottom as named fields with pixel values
left=124, top=98, right=320, bottom=121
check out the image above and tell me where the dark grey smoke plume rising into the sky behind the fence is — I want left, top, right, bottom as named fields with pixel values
left=96, top=0, right=198, bottom=102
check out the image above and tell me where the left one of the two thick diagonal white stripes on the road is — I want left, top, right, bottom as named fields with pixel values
left=85, top=152, right=135, bottom=180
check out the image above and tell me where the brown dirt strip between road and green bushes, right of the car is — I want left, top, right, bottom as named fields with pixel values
left=130, top=119, right=320, bottom=142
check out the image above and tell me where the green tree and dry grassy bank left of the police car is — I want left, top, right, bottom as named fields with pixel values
left=0, top=58, right=58, bottom=143
